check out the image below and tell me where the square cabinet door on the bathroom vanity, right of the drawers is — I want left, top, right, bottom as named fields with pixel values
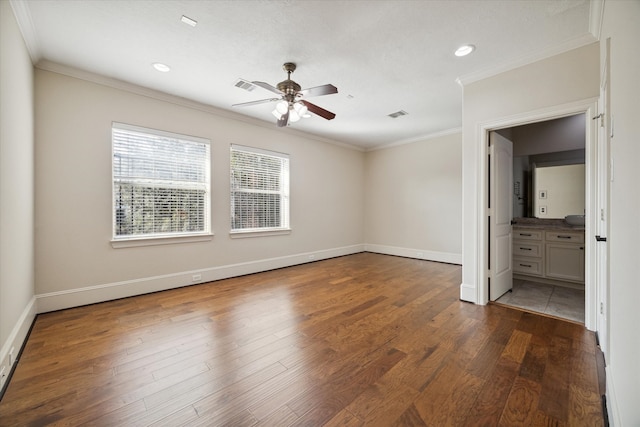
left=545, top=243, right=584, bottom=282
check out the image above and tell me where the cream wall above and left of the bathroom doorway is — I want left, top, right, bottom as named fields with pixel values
left=461, top=43, right=599, bottom=303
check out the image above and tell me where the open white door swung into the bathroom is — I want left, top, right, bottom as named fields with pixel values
left=488, top=132, right=513, bottom=301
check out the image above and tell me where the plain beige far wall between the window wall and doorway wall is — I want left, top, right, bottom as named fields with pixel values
left=365, top=132, right=462, bottom=264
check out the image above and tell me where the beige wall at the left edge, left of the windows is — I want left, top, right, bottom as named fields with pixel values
left=0, top=1, right=35, bottom=392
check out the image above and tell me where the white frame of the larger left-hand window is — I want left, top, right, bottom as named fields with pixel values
left=111, top=122, right=213, bottom=248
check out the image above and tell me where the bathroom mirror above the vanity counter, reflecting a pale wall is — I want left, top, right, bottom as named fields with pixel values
left=531, top=163, right=585, bottom=219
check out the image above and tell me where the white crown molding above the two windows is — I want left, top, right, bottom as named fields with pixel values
left=35, top=60, right=365, bottom=152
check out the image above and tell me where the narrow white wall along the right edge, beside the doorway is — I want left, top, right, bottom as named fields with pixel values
left=601, top=0, right=640, bottom=426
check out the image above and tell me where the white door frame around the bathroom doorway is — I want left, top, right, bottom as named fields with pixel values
left=475, top=98, right=606, bottom=331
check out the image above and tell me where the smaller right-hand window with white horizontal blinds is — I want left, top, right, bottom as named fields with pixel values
left=231, top=145, right=289, bottom=233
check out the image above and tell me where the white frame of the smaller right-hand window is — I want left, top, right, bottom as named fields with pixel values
left=229, top=144, right=291, bottom=238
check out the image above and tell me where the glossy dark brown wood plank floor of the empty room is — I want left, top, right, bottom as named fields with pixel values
left=0, top=253, right=603, bottom=426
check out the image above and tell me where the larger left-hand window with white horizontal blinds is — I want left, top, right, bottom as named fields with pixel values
left=112, top=123, right=210, bottom=241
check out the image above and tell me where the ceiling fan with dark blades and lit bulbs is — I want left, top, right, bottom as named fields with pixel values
left=232, top=62, right=338, bottom=127
